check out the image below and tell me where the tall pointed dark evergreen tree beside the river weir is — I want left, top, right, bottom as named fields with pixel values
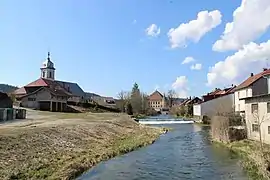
left=130, top=83, right=142, bottom=114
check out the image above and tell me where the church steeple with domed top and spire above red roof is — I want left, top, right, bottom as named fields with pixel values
left=40, top=52, right=55, bottom=80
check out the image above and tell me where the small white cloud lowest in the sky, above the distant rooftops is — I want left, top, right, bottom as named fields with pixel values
left=172, top=76, right=188, bottom=97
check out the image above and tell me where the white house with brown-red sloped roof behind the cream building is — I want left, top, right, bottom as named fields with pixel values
left=234, top=68, right=270, bottom=116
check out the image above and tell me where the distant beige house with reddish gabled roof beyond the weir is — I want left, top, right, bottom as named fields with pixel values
left=148, top=90, right=168, bottom=111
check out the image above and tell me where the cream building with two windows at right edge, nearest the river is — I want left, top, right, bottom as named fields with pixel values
left=241, top=93, right=270, bottom=144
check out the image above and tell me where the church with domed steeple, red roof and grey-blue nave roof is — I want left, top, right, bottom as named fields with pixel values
left=14, top=52, right=85, bottom=112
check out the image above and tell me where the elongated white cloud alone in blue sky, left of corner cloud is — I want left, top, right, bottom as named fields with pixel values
left=168, top=10, right=222, bottom=48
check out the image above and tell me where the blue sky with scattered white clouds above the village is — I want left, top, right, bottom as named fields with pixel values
left=0, top=0, right=270, bottom=97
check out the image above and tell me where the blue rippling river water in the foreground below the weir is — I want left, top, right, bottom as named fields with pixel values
left=78, top=124, right=248, bottom=180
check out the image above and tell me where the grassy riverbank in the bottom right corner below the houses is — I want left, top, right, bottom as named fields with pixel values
left=217, top=140, right=270, bottom=180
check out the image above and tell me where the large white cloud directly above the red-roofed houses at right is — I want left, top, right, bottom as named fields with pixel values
left=207, top=40, right=270, bottom=86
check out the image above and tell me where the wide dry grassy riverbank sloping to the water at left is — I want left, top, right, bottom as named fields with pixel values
left=0, top=111, right=160, bottom=179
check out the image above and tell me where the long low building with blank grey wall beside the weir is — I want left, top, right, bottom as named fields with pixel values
left=193, top=86, right=236, bottom=118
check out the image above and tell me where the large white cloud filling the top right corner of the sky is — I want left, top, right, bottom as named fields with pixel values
left=213, top=0, right=270, bottom=51
